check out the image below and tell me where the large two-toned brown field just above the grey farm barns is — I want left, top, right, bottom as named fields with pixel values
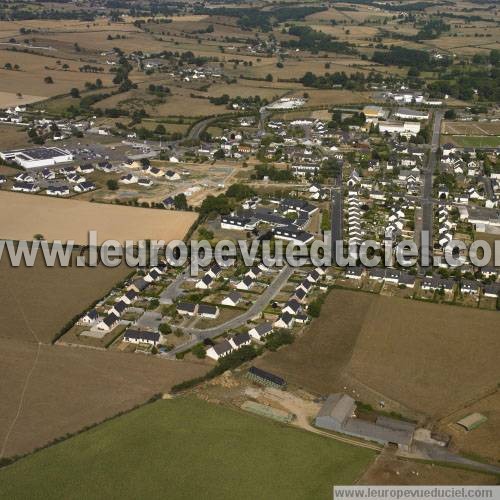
left=257, top=290, right=500, bottom=418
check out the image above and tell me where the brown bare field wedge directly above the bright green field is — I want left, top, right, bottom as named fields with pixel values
left=0, top=338, right=206, bottom=458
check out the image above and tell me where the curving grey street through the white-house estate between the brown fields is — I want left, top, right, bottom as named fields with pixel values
left=168, top=266, right=294, bottom=357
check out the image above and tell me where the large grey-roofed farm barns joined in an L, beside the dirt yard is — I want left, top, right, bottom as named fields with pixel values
left=316, top=393, right=415, bottom=451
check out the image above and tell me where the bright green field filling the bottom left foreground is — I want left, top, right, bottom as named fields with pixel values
left=0, top=398, right=375, bottom=500
